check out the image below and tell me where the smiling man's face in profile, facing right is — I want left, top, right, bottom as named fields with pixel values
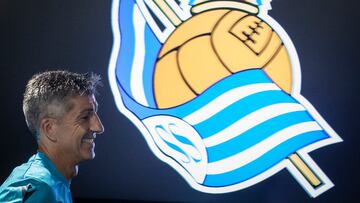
left=56, top=95, right=104, bottom=164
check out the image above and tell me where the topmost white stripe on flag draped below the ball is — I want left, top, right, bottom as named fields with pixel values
left=184, top=83, right=280, bottom=125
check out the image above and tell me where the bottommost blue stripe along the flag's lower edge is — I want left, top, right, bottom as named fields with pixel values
left=203, top=131, right=329, bottom=187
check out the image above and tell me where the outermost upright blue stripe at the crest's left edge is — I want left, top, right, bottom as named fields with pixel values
left=116, top=0, right=135, bottom=98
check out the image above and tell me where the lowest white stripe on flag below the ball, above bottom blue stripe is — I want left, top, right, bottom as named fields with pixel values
left=207, top=121, right=321, bottom=174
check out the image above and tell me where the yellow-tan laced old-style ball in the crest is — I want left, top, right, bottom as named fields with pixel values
left=154, top=9, right=292, bottom=108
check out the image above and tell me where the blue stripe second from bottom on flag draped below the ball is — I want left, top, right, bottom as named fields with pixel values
left=207, top=111, right=313, bottom=163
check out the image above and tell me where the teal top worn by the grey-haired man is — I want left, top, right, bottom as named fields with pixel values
left=0, top=152, right=72, bottom=203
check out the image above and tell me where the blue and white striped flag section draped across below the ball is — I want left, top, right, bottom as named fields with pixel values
left=133, top=69, right=329, bottom=187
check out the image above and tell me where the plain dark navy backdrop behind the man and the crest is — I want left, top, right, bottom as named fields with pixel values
left=0, top=0, right=360, bottom=202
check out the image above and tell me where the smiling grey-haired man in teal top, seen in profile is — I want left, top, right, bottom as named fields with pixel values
left=0, top=71, right=104, bottom=203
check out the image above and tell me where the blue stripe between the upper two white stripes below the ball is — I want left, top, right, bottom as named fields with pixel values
left=194, top=90, right=298, bottom=138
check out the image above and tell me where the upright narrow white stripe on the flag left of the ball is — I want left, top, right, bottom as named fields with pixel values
left=129, top=6, right=149, bottom=106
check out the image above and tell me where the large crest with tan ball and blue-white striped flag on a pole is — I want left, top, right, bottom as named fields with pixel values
left=109, top=0, right=342, bottom=197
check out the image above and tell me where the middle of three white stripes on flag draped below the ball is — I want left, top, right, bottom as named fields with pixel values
left=204, top=103, right=305, bottom=147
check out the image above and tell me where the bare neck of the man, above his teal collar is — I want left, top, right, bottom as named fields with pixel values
left=38, top=145, right=78, bottom=181
